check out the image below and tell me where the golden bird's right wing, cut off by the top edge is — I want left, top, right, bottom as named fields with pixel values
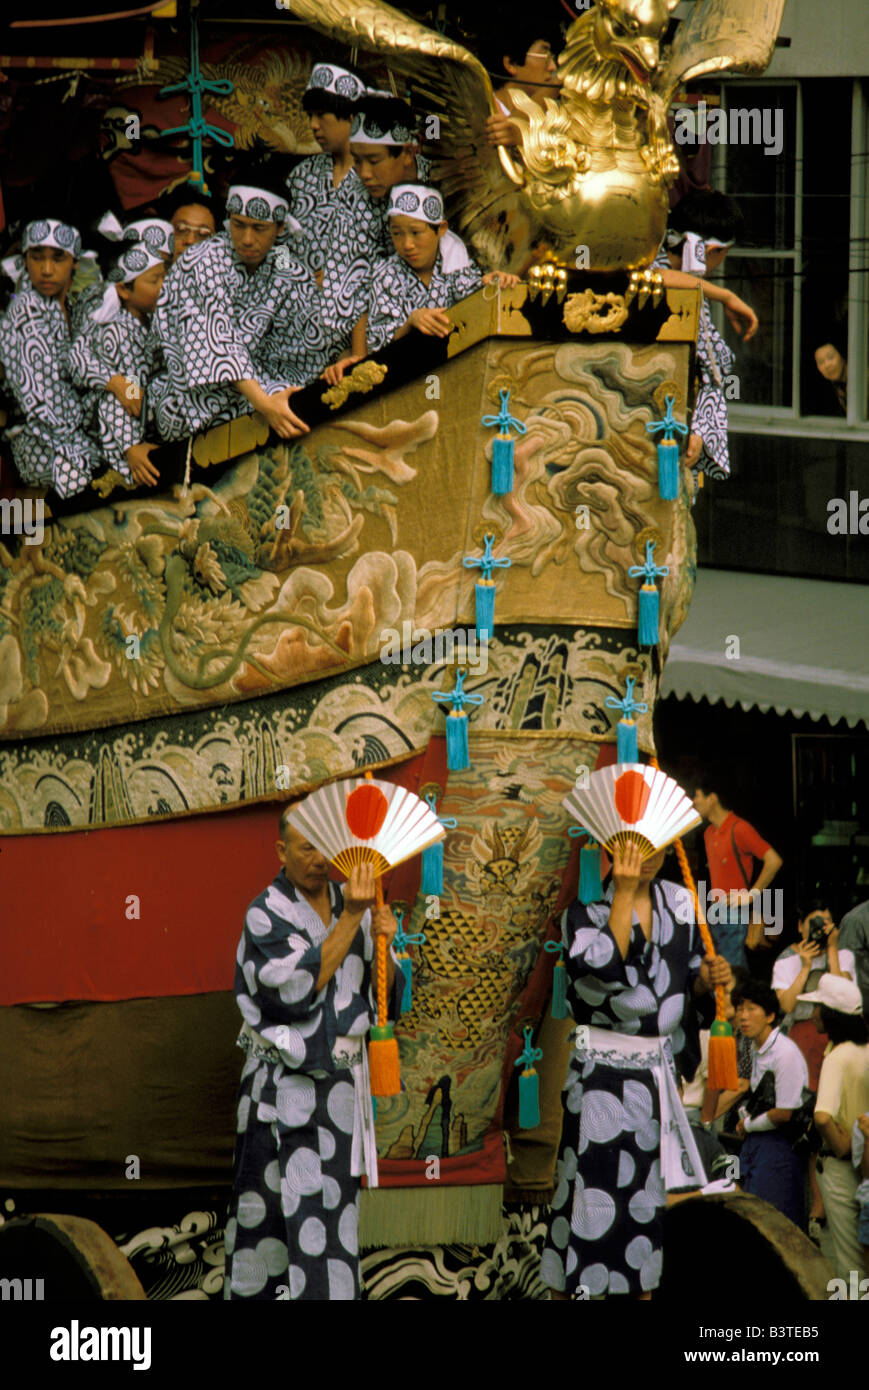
left=655, top=0, right=784, bottom=97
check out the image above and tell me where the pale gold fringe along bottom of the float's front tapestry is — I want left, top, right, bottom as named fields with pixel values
left=359, top=1180, right=503, bottom=1250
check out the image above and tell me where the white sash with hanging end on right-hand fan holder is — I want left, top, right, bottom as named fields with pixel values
left=576, top=1024, right=708, bottom=1191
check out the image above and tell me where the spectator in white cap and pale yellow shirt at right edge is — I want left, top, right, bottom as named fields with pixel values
left=799, top=974, right=869, bottom=1280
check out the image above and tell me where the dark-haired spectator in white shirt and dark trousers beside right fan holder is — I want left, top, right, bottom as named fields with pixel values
left=733, top=980, right=808, bottom=1227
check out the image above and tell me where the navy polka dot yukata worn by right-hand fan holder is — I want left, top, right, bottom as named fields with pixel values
left=541, top=880, right=712, bottom=1295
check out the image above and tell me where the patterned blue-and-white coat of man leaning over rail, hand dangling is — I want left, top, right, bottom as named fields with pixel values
left=150, top=232, right=328, bottom=439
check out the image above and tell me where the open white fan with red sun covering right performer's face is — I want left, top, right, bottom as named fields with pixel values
left=562, top=763, right=701, bottom=859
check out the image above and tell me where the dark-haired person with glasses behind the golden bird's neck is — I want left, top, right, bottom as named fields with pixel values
left=482, top=15, right=562, bottom=145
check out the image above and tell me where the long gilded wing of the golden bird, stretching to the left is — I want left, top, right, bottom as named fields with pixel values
left=286, top=0, right=539, bottom=270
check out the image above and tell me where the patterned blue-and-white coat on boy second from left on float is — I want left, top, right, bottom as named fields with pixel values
left=70, top=300, right=152, bottom=478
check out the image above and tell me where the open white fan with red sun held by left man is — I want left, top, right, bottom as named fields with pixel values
left=288, top=777, right=446, bottom=876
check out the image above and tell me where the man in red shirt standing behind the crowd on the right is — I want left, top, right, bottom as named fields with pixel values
left=694, top=780, right=781, bottom=966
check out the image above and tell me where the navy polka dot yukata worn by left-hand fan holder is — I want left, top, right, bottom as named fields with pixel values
left=224, top=872, right=405, bottom=1301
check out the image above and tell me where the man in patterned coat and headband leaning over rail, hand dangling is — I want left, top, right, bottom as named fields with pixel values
left=152, top=174, right=327, bottom=439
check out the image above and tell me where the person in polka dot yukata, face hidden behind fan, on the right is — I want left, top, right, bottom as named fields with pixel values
left=541, top=765, right=729, bottom=1300
